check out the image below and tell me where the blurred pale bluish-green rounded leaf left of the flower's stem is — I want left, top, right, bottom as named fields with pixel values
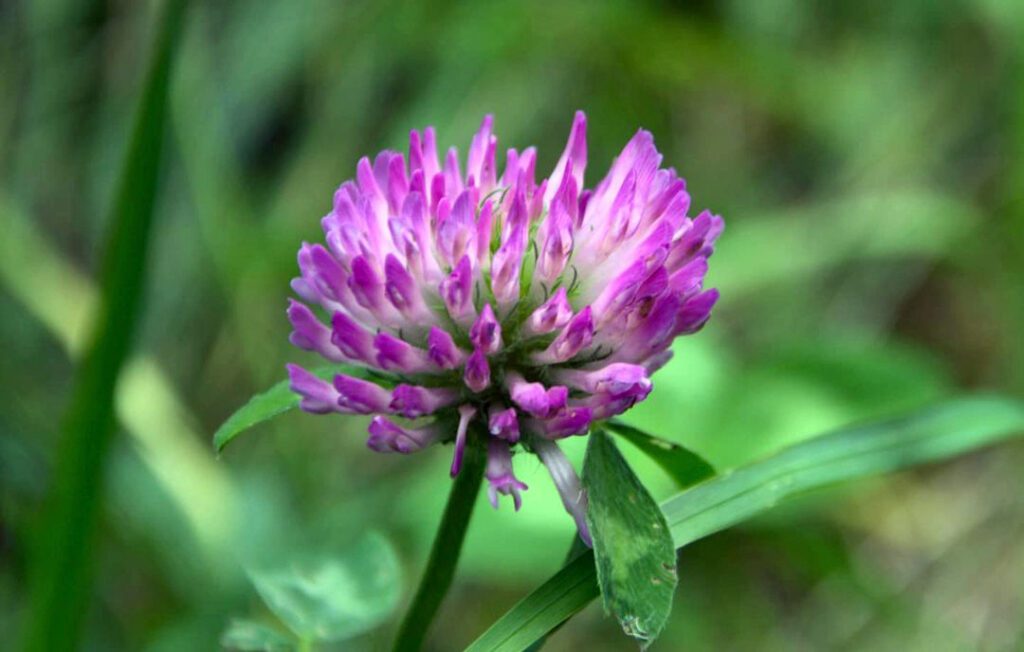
left=249, top=533, right=401, bottom=641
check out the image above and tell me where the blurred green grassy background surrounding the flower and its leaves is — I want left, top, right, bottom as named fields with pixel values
left=6, top=0, right=1024, bottom=651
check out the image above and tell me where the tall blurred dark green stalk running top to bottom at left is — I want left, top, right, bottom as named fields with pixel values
left=24, top=0, right=186, bottom=652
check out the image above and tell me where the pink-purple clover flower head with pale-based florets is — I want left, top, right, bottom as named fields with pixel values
left=288, top=112, right=723, bottom=540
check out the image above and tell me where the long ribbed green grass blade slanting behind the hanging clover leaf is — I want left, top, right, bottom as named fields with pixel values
left=468, top=396, right=1024, bottom=652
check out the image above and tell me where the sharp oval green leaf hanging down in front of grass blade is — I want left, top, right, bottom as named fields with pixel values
left=583, top=429, right=678, bottom=648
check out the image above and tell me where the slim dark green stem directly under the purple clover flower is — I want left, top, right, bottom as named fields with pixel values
left=393, top=429, right=486, bottom=652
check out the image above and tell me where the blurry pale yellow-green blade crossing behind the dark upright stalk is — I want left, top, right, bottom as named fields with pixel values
left=0, top=191, right=242, bottom=589
